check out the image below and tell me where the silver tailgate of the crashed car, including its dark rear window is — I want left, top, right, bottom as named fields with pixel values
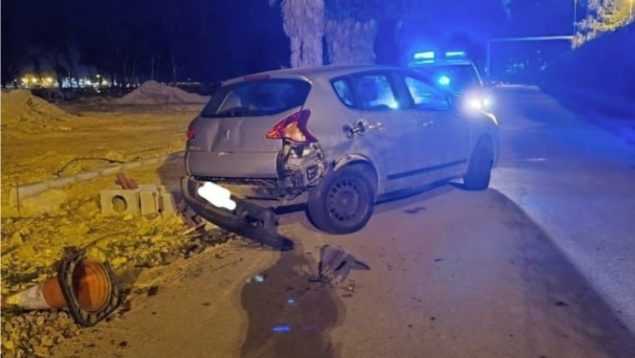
left=186, top=79, right=311, bottom=178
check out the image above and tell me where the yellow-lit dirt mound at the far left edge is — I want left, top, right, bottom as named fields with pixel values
left=1, top=90, right=74, bottom=132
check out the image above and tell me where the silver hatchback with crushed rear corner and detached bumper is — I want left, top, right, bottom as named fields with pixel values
left=183, top=66, right=498, bottom=234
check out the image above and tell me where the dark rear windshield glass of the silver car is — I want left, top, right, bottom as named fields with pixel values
left=201, top=79, right=311, bottom=117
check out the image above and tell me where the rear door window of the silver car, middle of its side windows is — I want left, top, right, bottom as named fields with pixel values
left=353, top=73, right=399, bottom=111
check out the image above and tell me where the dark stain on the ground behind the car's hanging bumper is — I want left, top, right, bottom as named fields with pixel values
left=241, top=245, right=340, bottom=357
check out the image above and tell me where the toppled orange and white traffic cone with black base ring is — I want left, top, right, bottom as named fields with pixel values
left=4, top=248, right=121, bottom=326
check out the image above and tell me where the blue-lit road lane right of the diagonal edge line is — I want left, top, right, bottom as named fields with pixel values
left=492, top=88, right=635, bottom=332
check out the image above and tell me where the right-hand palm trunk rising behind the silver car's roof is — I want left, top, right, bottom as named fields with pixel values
left=326, top=19, right=377, bottom=65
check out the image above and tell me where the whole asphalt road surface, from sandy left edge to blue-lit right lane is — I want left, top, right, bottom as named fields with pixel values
left=57, top=86, right=635, bottom=358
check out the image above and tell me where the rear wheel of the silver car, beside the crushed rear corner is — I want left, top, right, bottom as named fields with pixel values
left=307, top=164, right=375, bottom=234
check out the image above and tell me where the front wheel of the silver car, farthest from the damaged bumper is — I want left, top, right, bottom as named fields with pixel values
left=463, top=138, right=494, bottom=190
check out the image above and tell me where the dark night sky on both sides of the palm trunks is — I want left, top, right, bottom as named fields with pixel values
left=2, top=0, right=573, bottom=83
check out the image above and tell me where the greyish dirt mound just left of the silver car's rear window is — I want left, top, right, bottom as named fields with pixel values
left=116, top=81, right=208, bottom=104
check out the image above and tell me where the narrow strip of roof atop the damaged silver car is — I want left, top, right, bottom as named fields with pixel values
left=223, top=65, right=407, bottom=86
